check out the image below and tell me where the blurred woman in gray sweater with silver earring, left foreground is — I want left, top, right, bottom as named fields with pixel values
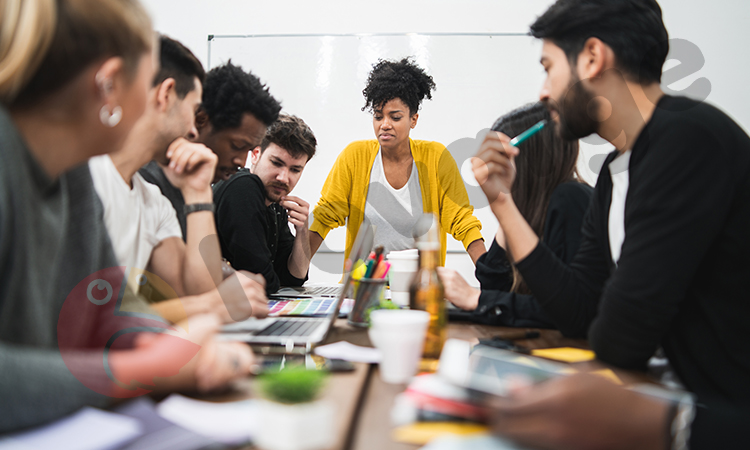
left=0, top=0, right=252, bottom=433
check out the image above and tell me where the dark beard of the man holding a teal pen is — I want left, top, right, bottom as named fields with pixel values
left=552, top=73, right=599, bottom=141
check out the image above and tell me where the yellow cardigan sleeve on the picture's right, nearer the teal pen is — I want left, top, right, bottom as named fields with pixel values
left=438, top=147, right=484, bottom=248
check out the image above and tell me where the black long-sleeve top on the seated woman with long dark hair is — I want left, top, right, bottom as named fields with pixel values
left=471, top=181, right=593, bottom=328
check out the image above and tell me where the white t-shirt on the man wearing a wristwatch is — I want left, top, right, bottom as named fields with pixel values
left=89, top=155, right=182, bottom=270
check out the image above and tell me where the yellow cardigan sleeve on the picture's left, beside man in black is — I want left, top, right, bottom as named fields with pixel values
left=310, top=143, right=356, bottom=239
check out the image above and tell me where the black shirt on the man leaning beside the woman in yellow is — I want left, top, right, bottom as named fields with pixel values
left=214, top=169, right=307, bottom=294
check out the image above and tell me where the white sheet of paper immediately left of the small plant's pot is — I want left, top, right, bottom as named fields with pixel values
left=156, top=394, right=258, bottom=445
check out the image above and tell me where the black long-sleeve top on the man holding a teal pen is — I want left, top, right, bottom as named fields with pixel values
left=517, top=96, right=750, bottom=448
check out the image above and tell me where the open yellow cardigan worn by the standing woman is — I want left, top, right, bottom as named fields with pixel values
left=310, top=139, right=482, bottom=265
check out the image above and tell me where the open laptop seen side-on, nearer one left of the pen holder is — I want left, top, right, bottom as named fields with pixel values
left=219, top=219, right=375, bottom=354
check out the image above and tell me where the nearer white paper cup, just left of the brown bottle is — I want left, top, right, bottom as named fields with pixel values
left=369, top=309, right=430, bottom=384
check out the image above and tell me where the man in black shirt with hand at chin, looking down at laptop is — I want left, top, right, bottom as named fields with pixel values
left=214, top=114, right=317, bottom=294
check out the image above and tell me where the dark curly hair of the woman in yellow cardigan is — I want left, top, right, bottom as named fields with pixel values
left=362, top=57, right=435, bottom=115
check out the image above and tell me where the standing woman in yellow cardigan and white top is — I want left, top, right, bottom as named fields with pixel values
left=310, top=58, right=486, bottom=265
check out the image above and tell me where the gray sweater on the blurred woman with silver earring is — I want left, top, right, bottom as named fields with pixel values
left=0, top=106, right=156, bottom=433
